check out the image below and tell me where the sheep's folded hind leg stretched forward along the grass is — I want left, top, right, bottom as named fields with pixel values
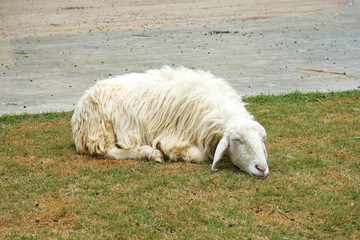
left=108, top=146, right=163, bottom=162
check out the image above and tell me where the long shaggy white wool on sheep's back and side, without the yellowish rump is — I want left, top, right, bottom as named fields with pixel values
left=76, top=67, right=247, bottom=149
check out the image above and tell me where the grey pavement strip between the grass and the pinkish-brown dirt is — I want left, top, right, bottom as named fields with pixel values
left=0, top=0, right=360, bottom=115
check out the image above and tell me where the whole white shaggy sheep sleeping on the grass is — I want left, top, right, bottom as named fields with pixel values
left=71, top=66, right=269, bottom=177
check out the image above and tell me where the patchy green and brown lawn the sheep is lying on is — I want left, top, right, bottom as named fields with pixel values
left=0, top=90, right=360, bottom=239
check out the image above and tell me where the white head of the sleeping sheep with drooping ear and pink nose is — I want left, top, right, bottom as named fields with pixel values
left=212, top=120, right=269, bottom=177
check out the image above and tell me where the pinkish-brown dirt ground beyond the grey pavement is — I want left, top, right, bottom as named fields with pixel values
left=0, top=0, right=346, bottom=39
